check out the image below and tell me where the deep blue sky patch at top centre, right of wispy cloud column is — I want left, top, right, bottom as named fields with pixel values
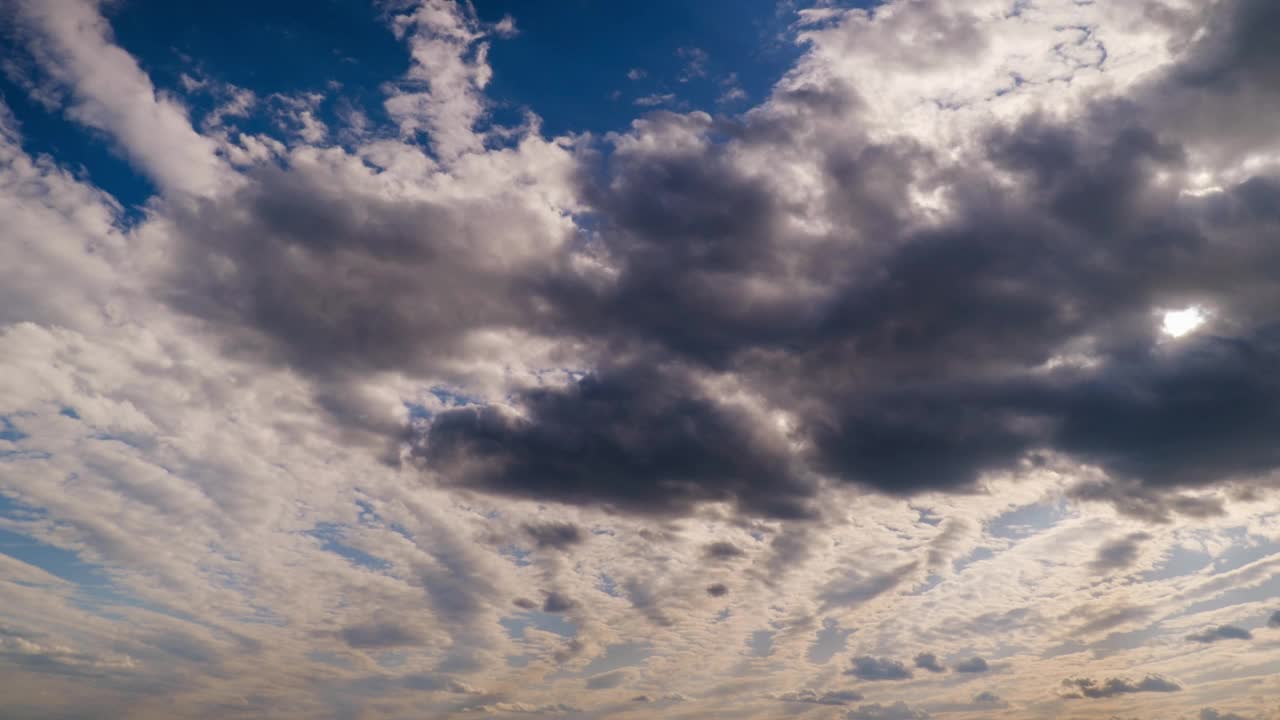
left=475, top=0, right=844, bottom=135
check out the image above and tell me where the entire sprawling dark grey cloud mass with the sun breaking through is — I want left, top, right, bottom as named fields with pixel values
left=163, top=0, right=1280, bottom=517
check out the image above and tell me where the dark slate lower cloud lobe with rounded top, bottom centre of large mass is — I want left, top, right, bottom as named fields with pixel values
left=416, top=366, right=814, bottom=518
